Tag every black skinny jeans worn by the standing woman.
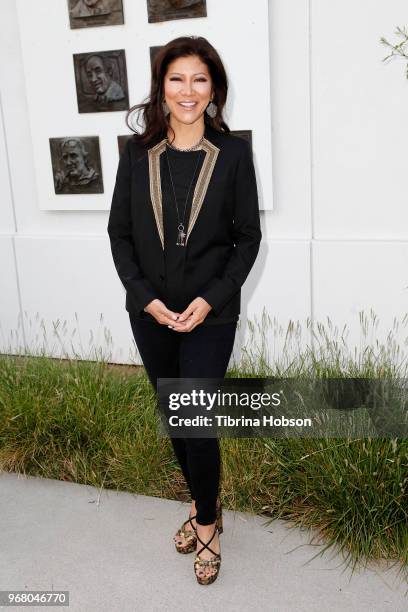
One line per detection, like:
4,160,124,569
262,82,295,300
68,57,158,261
129,313,237,525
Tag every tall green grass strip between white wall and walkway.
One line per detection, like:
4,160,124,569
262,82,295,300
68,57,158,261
0,308,408,577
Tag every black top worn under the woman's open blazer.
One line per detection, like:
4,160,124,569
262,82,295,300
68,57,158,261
142,145,238,326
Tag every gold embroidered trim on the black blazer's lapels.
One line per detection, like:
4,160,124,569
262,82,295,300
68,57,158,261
148,138,220,249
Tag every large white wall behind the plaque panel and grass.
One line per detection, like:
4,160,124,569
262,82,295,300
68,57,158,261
0,0,408,363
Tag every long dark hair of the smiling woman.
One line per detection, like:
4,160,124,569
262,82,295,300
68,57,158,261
126,36,230,145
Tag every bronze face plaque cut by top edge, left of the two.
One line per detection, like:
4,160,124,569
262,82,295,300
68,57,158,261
67,0,124,29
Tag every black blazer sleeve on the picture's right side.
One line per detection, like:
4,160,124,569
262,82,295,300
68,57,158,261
200,140,262,316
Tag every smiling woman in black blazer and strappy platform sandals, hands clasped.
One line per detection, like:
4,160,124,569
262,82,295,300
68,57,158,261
108,36,261,584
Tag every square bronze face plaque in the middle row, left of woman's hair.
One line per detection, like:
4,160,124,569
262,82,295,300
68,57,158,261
73,49,129,113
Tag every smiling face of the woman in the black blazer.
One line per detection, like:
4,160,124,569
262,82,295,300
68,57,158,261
163,55,212,124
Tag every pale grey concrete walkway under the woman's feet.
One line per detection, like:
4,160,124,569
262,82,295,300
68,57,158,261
0,472,408,612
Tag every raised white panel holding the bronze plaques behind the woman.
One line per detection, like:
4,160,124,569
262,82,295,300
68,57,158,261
16,0,273,211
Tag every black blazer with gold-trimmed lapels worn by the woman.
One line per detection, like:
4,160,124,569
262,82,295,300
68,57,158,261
107,120,262,321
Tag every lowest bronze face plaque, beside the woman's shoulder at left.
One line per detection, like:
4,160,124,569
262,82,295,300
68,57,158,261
49,136,103,195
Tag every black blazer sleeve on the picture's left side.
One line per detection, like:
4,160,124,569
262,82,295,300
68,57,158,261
107,141,158,312
